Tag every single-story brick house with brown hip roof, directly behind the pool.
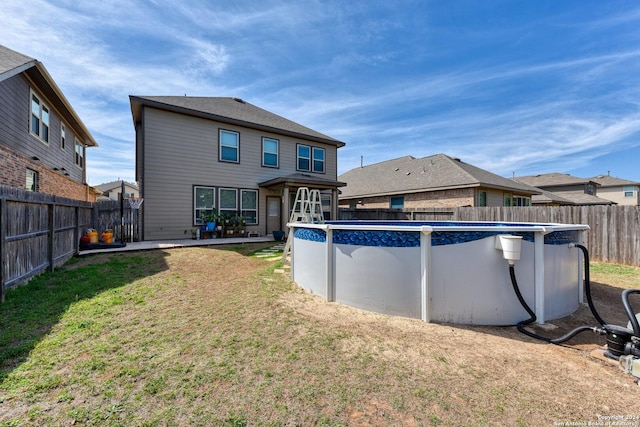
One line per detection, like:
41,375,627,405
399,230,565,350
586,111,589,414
338,154,541,209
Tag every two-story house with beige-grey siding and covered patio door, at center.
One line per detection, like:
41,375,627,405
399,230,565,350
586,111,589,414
130,96,344,240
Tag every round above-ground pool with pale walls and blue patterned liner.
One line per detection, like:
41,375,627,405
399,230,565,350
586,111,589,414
288,221,589,325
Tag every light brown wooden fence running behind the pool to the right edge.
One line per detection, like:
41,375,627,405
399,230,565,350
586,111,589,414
338,206,640,266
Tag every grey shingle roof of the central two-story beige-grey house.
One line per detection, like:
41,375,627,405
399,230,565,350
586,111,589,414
129,95,345,147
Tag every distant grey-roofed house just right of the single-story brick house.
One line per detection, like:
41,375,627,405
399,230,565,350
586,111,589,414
512,172,615,206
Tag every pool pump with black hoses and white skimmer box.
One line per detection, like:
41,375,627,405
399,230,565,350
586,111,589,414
495,235,640,385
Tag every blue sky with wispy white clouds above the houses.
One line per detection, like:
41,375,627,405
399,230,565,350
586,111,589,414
0,0,640,185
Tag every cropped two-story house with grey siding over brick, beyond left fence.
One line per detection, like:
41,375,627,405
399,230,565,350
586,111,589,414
0,45,98,201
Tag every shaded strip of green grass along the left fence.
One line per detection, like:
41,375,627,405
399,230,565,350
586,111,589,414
0,251,167,382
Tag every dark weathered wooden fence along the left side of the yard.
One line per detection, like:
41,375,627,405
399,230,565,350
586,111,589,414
0,186,138,301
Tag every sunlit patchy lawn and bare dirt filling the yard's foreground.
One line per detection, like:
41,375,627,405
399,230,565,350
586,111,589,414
0,247,640,427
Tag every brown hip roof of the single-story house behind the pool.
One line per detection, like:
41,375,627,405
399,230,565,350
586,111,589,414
338,154,541,199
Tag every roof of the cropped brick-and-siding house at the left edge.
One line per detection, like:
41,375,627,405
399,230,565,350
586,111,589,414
0,45,98,147
